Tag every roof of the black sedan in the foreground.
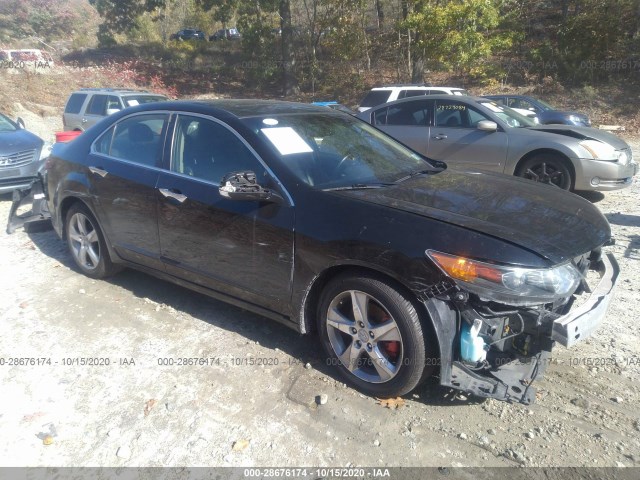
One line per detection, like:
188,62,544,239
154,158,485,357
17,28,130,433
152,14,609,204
124,99,332,118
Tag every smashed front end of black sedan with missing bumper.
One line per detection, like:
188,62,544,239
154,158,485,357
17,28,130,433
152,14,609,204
424,248,619,405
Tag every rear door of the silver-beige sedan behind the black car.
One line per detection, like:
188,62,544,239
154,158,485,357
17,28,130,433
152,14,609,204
371,99,433,155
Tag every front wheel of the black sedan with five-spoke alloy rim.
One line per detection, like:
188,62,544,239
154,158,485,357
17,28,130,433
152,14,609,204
318,275,435,397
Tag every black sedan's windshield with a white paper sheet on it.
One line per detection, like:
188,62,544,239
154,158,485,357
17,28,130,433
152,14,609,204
244,113,442,189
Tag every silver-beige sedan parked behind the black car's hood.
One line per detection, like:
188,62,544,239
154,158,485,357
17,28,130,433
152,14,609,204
358,95,638,190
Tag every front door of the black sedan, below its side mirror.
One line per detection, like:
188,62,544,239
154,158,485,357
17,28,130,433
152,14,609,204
157,114,294,310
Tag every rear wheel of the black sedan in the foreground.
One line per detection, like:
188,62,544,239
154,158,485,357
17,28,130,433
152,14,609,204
65,203,117,278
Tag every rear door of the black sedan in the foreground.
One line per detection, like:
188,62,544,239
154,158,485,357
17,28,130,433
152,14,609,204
88,113,169,269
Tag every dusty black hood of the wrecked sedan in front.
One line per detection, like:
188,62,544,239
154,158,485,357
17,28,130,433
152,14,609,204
340,170,611,264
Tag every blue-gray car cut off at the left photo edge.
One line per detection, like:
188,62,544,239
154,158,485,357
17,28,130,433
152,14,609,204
0,114,51,193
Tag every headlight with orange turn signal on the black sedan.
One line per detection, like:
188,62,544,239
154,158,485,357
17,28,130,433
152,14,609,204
426,250,581,305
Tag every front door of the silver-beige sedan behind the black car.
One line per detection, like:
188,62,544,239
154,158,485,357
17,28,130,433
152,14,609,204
427,99,508,172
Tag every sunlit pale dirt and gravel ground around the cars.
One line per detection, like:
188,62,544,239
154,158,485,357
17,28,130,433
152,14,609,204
0,98,640,467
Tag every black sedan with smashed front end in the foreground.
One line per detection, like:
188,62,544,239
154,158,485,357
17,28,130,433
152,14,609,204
11,100,618,403
